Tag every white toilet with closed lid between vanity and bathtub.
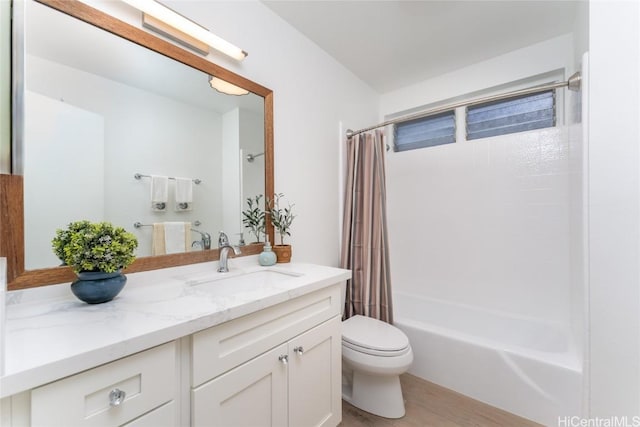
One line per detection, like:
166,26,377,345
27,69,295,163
342,315,413,418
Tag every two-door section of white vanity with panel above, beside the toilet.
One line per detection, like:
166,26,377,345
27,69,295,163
191,287,342,427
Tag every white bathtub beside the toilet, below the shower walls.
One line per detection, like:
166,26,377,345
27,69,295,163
393,292,582,426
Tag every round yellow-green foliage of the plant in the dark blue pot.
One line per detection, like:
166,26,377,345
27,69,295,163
51,220,138,273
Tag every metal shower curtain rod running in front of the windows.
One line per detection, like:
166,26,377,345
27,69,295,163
347,71,581,138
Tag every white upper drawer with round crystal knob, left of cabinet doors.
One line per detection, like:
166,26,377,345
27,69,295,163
31,342,177,426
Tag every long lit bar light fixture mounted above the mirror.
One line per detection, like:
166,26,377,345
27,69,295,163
122,0,247,61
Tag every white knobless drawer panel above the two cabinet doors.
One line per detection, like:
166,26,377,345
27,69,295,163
191,285,340,387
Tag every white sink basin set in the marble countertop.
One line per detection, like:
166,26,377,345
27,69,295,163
187,269,301,296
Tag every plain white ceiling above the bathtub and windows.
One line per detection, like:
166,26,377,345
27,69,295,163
263,0,578,93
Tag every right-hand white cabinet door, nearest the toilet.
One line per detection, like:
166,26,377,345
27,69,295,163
289,317,342,427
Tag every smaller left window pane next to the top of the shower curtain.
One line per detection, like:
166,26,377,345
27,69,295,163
393,110,456,151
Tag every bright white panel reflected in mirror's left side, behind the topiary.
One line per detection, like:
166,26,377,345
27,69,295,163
24,91,105,270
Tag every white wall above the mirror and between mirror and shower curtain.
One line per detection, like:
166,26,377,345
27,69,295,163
80,0,379,265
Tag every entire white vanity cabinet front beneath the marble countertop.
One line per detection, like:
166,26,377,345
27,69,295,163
0,274,342,427
